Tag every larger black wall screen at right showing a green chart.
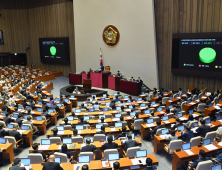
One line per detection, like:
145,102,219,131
172,33,222,77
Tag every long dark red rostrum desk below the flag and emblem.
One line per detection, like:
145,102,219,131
69,71,141,96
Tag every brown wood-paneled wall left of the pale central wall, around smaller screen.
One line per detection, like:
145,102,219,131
0,0,76,75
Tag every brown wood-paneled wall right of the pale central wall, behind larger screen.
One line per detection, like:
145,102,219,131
155,0,222,91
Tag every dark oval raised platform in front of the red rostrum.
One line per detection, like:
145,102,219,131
60,85,107,101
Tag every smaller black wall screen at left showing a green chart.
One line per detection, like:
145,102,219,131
39,37,70,65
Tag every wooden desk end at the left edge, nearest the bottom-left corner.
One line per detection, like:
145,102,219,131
0,143,14,163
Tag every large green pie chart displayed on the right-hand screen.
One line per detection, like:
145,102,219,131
199,47,216,63
